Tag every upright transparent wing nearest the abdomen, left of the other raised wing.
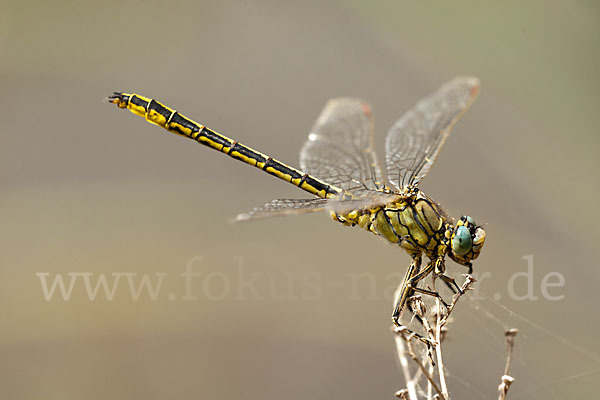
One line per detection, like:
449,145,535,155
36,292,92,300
300,98,383,194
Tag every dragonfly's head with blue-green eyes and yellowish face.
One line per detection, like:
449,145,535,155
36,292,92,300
450,215,485,265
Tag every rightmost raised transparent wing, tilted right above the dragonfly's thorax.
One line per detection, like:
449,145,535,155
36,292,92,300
385,77,479,188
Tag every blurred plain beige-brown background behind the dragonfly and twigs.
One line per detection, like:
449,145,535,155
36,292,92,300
0,0,600,399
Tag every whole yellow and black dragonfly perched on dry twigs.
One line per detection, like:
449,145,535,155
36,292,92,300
107,77,485,329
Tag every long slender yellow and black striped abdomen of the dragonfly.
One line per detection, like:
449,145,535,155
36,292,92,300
108,92,342,198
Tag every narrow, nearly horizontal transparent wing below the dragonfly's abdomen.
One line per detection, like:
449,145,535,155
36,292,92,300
234,192,397,222
